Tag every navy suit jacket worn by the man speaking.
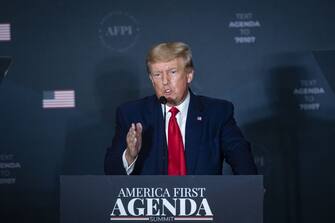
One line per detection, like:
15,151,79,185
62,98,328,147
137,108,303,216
105,93,257,175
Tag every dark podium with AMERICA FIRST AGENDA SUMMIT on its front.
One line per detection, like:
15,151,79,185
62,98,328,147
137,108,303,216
60,175,264,223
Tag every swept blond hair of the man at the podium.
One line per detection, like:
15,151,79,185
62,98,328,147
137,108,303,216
146,42,193,74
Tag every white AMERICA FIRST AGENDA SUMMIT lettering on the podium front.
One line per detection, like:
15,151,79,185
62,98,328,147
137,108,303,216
110,187,214,222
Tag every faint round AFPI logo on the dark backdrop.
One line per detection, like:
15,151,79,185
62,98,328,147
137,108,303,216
99,12,140,51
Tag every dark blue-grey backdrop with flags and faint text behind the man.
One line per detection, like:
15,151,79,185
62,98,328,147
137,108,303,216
0,0,335,223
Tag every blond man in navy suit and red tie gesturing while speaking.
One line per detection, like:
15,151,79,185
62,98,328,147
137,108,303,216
105,42,257,175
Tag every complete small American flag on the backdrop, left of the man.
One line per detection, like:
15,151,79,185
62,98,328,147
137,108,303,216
43,90,75,108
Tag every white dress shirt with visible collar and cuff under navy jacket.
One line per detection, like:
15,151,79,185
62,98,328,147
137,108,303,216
122,92,190,175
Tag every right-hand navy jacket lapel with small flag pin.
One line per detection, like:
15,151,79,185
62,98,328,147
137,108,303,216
185,92,204,175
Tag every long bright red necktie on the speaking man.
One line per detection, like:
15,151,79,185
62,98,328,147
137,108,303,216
168,107,186,176
